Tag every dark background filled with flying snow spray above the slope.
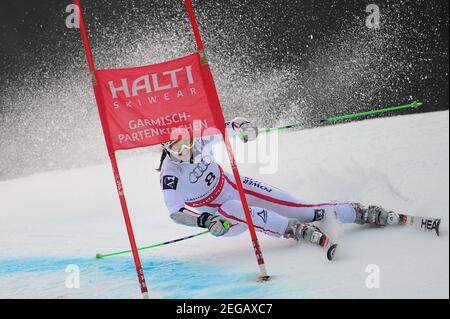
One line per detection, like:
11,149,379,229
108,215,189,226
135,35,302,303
0,0,449,179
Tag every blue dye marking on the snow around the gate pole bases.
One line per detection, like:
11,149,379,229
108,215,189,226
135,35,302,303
0,257,282,299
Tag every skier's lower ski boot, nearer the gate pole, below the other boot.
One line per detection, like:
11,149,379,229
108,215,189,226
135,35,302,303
284,218,337,261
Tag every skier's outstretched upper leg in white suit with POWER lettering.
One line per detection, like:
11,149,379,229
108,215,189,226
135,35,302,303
225,174,356,223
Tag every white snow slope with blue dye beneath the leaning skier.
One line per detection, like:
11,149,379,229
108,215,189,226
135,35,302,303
0,111,449,298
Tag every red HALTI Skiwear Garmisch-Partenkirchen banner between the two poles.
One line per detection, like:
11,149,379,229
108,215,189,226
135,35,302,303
95,53,223,151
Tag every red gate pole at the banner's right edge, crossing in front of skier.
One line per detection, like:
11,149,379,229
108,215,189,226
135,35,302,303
185,0,270,281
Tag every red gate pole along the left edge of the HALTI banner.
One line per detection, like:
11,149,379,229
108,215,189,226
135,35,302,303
74,0,149,299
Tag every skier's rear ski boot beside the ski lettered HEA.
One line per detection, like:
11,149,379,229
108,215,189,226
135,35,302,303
352,203,404,226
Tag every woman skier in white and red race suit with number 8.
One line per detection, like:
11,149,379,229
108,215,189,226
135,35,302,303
159,118,401,247
